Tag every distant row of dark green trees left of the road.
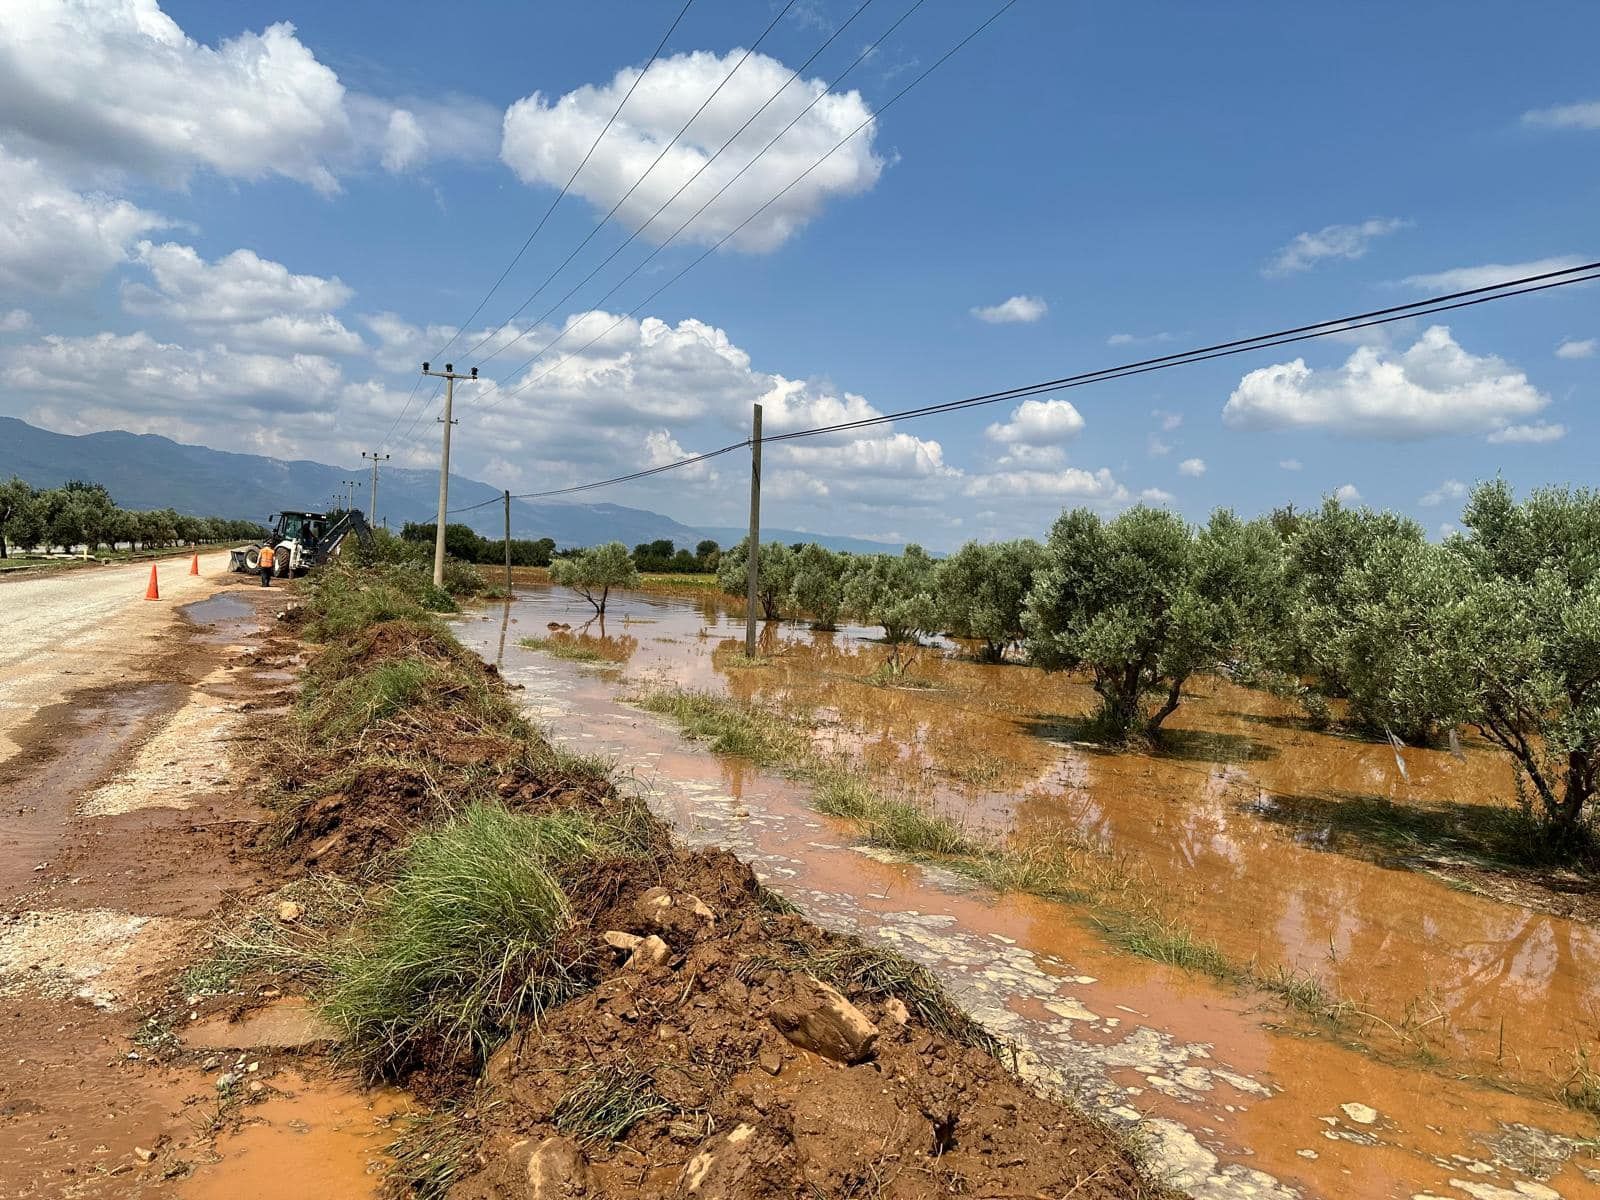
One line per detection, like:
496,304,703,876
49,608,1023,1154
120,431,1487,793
0,475,267,558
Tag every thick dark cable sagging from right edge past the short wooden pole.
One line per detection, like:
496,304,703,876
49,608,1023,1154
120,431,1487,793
486,261,1600,499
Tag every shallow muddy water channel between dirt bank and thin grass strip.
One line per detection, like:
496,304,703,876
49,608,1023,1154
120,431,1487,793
461,605,1600,1200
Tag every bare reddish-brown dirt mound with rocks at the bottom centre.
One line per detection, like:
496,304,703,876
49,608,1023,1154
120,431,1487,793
450,851,1147,1200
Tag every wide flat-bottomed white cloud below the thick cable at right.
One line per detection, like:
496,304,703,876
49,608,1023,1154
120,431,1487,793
1222,325,1549,438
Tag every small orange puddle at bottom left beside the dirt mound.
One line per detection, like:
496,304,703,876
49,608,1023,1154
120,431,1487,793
178,1072,411,1200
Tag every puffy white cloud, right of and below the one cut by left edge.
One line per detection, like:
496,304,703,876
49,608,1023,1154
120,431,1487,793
122,242,366,354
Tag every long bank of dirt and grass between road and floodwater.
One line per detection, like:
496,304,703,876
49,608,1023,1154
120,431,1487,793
186,539,1162,1200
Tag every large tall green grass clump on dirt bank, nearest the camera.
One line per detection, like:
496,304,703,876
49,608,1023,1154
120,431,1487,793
318,803,595,1075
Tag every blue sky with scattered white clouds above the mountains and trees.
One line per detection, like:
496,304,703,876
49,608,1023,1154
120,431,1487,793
0,0,1600,549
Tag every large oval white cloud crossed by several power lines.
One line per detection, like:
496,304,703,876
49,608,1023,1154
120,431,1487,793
501,48,883,253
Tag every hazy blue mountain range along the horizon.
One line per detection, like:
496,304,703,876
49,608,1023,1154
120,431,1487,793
0,416,901,554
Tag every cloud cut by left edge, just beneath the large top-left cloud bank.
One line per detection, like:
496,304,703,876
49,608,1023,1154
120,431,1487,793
0,146,166,296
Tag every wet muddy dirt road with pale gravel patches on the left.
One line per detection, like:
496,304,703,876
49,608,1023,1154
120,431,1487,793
0,554,408,1200
